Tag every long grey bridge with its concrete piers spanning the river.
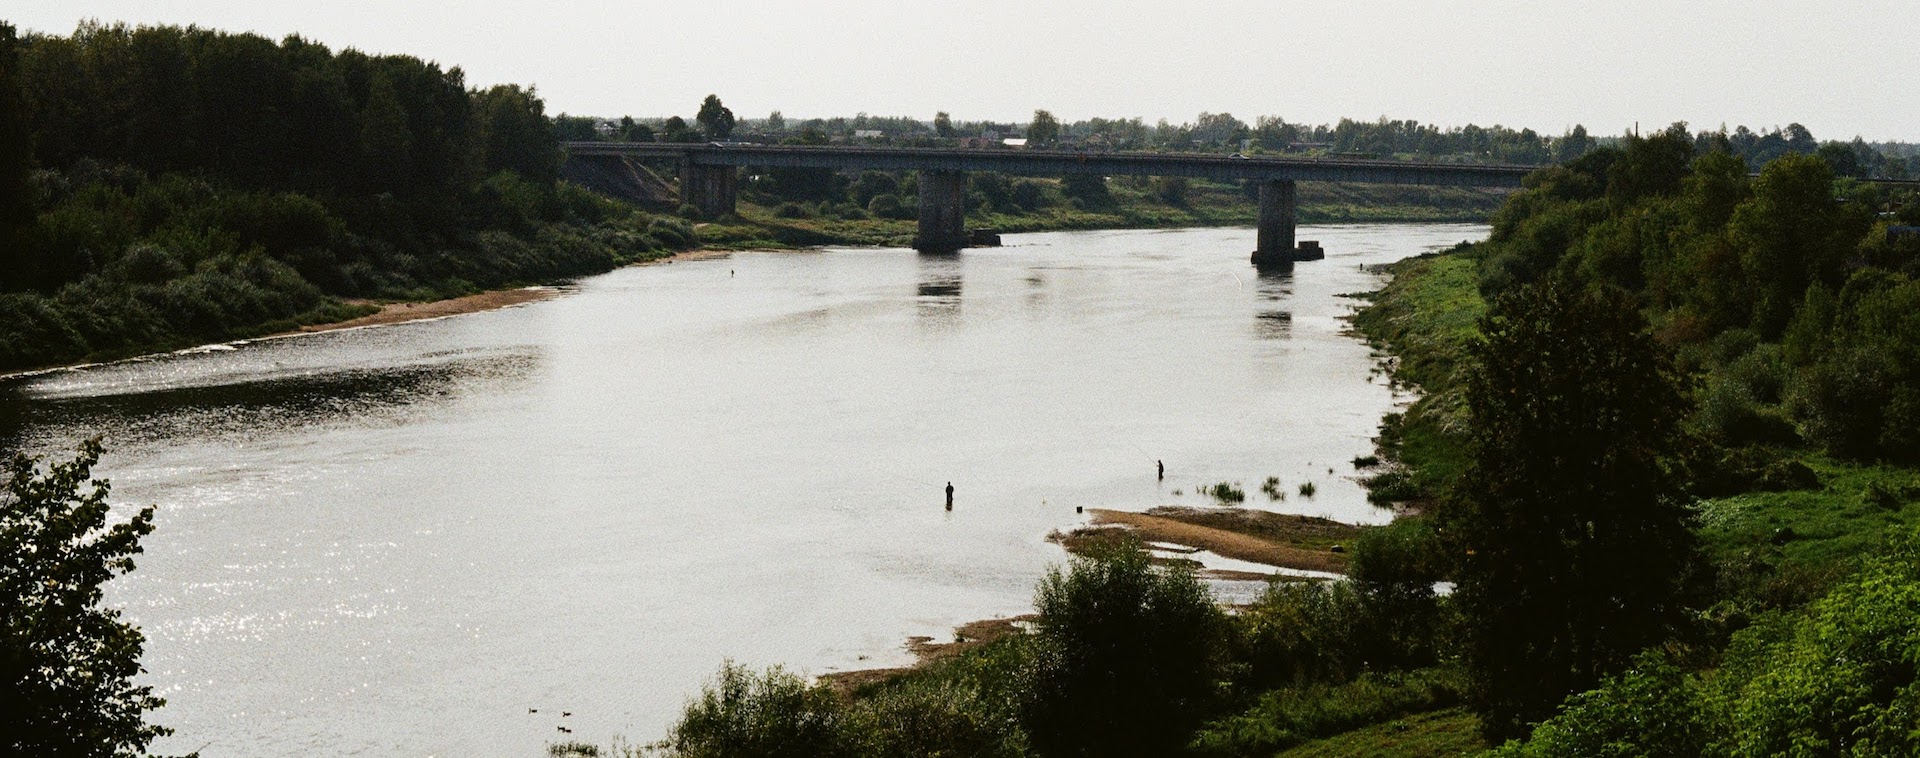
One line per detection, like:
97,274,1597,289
564,142,1538,265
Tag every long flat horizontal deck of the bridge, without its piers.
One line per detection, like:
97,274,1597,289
564,142,1538,186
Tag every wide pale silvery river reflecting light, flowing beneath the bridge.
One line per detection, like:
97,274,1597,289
0,225,1486,758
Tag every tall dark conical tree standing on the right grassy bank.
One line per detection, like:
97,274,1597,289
1446,280,1697,743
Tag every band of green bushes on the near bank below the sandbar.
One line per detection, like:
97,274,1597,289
645,532,1461,758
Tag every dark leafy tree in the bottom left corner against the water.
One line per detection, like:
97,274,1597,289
0,439,169,756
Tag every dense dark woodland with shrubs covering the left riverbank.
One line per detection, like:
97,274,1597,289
0,23,691,376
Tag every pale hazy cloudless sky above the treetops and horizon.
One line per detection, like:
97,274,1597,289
0,0,1920,142
